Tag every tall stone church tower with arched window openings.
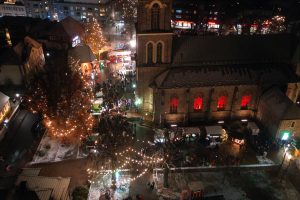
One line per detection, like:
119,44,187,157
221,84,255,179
137,0,173,113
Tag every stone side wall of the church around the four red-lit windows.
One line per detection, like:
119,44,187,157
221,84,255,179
154,85,257,124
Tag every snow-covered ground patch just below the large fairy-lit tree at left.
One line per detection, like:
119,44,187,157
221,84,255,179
31,135,78,164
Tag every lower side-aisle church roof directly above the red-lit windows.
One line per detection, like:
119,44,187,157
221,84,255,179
150,64,298,89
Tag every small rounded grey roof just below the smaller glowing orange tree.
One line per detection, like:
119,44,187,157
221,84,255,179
68,44,96,63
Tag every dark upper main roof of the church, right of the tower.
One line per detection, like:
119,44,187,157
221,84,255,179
172,34,294,66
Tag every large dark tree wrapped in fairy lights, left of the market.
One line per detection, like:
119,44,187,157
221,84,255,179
25,52,94,143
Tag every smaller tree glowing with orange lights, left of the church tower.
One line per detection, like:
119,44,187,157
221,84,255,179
84,18,109,56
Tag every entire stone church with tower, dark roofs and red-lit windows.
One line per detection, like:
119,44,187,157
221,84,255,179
137,0,300,130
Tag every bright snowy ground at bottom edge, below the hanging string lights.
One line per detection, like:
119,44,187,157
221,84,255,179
88,170,130,200
